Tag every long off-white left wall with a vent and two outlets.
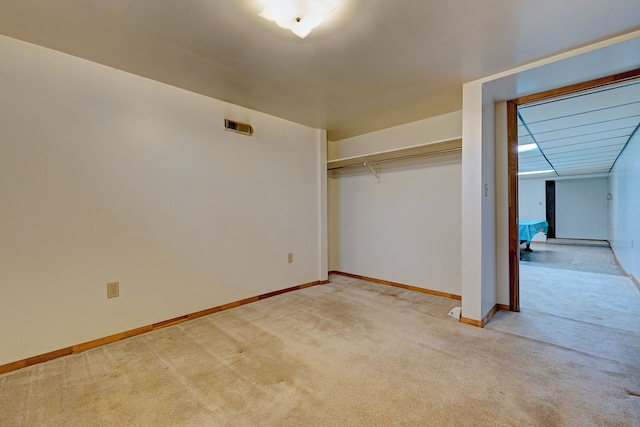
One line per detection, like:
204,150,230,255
0,37,326,364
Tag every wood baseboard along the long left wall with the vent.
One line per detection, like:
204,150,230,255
0,280,329,375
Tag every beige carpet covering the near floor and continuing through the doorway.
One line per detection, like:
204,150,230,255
0,254,640,427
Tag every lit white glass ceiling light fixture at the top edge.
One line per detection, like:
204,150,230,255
258,0,339,39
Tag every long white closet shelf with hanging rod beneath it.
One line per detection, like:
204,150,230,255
327,138,462,171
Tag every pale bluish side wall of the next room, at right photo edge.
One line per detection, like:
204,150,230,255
609,132,640,279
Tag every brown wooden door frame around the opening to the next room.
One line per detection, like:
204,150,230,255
507,68,640,311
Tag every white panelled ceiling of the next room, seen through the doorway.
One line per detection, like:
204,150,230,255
518,79,640,176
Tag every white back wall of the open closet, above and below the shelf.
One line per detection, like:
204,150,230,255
328,115,461,295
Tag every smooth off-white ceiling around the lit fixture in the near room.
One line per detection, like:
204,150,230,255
0,0,640,140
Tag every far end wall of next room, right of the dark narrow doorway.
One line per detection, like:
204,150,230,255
556,177,609,240
